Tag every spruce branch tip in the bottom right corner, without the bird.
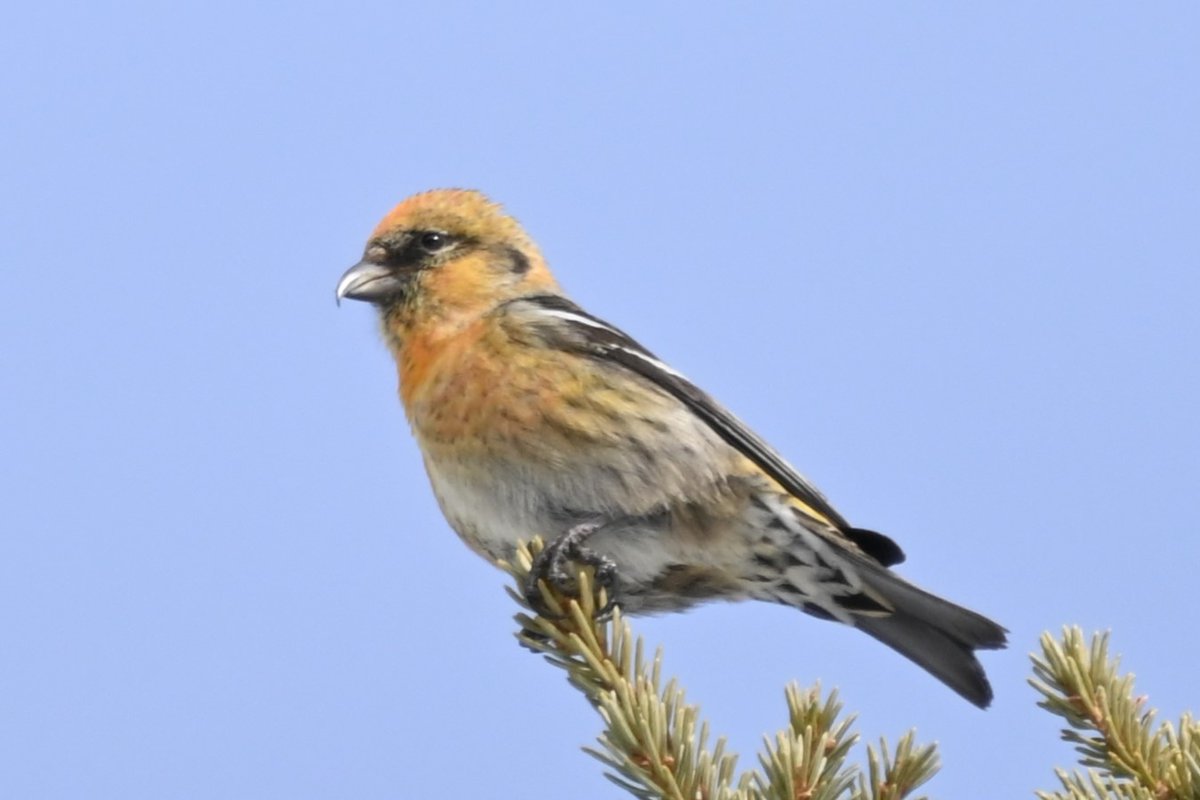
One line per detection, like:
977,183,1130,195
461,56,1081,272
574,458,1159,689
1030,627,1200,800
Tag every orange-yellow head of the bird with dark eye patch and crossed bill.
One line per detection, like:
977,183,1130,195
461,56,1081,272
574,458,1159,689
337,190,558,323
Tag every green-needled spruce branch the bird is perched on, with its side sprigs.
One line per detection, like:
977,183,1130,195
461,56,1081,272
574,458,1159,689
504,539,938,800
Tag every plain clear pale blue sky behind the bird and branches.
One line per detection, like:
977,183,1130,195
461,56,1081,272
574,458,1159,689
0,2,1200,800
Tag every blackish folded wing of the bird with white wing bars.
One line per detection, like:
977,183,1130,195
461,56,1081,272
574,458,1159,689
509,295,904,566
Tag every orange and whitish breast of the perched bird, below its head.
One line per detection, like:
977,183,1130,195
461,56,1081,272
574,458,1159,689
401,316,737,558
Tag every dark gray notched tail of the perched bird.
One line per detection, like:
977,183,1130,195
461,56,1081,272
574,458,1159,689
854,567,1007,709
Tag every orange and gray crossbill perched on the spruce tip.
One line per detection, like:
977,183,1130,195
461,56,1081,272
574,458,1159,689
336,188,1007,708
